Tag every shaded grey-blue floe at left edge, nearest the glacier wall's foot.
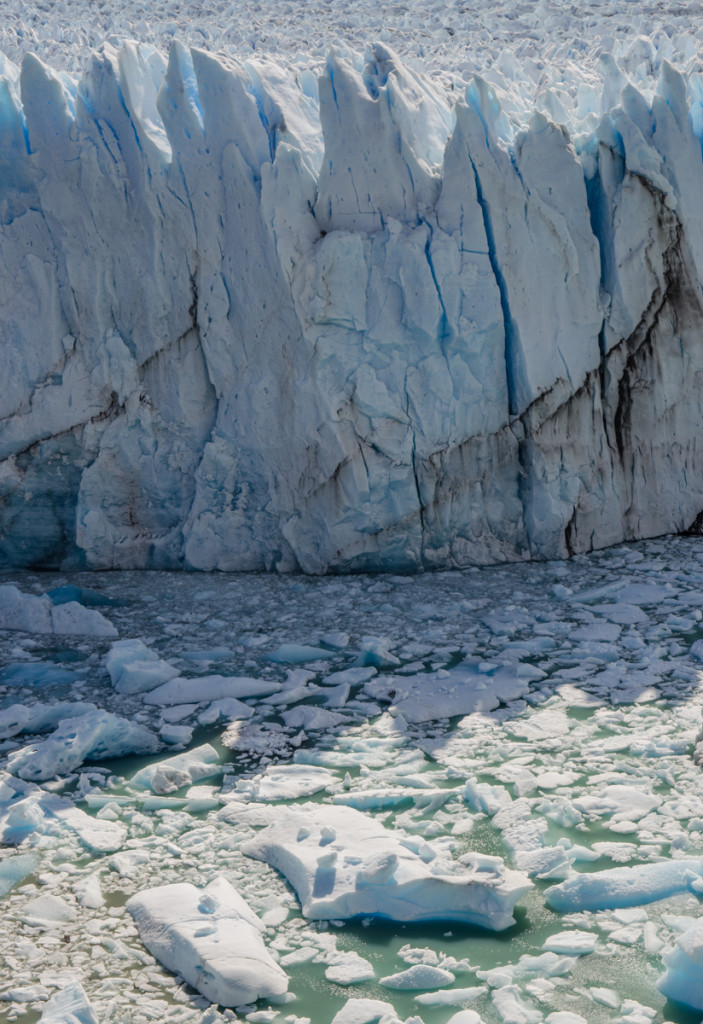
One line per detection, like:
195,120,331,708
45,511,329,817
0,584,118,637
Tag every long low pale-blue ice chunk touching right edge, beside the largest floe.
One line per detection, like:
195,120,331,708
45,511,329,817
545,859,703,913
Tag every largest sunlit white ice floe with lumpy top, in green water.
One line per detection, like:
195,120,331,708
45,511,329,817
241,804,532,931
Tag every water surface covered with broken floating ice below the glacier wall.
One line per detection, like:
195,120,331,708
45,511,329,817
0,538,703,1024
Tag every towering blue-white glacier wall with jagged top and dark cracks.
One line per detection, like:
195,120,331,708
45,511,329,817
0,44,703,572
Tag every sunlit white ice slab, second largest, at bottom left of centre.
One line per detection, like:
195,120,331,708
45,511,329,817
126,877,288,1007
